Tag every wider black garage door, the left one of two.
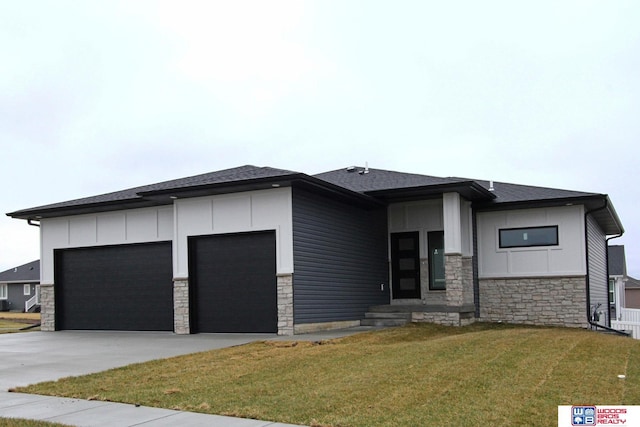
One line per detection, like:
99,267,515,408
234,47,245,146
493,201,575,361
55,242,173,331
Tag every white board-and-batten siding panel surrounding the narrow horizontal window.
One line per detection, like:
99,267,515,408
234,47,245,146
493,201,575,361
477,205,586,279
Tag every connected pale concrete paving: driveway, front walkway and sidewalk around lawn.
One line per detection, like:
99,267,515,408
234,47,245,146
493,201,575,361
0,327,379,427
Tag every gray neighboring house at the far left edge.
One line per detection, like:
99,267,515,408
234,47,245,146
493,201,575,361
0,261,40,312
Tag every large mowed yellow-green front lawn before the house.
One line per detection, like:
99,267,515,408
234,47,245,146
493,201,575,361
17,324,640,427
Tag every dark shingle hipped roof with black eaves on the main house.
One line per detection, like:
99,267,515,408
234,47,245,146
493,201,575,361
7,165,623,235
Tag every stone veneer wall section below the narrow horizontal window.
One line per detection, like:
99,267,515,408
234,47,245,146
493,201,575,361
479,276,587,327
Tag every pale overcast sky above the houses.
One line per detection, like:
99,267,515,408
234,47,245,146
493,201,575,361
0,0,640,277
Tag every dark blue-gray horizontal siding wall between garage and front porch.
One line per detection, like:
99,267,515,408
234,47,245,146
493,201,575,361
293,188,389,324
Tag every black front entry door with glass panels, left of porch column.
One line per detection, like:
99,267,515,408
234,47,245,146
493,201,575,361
391,231,420,299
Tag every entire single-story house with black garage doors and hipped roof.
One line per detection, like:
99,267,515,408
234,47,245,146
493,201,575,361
8,166,624,335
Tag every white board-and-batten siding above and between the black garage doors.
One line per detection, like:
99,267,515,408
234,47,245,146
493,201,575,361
40,188,293,283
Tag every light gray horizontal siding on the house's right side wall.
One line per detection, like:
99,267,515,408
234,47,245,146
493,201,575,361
586,215,609,325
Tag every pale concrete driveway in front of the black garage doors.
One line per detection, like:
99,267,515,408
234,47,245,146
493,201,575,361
0,331,278,391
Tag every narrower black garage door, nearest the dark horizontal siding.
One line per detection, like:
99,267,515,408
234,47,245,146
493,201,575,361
189,231,278,332
